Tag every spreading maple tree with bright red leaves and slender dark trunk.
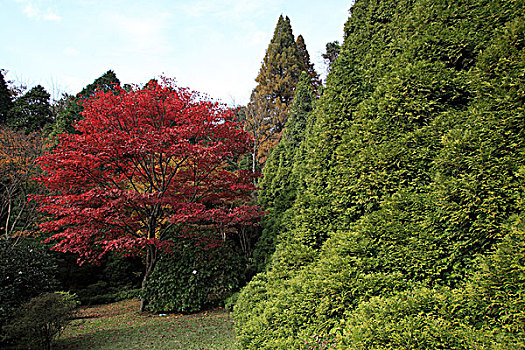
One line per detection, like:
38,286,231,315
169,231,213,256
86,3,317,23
35,80,262,309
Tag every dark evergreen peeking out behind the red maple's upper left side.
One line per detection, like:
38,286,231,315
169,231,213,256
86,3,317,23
53,70,120,135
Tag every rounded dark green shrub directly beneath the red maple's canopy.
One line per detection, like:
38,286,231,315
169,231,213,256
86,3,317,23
145,239,247,312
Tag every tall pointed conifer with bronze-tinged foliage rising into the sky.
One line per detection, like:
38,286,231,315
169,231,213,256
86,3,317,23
246,15,316,170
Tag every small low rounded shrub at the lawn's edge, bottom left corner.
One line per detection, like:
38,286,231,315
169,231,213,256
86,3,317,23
4,293,78,349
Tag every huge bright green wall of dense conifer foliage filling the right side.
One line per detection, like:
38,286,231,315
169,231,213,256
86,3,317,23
234,0,525,349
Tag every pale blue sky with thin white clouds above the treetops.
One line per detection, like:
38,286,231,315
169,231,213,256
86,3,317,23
0,0,351,105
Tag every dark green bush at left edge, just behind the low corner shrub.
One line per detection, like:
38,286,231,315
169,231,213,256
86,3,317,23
0,239,57,338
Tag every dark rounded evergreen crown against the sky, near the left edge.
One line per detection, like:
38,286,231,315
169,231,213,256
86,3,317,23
7,85,53,134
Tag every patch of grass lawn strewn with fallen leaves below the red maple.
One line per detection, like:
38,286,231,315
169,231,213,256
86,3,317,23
55,300,235,350
